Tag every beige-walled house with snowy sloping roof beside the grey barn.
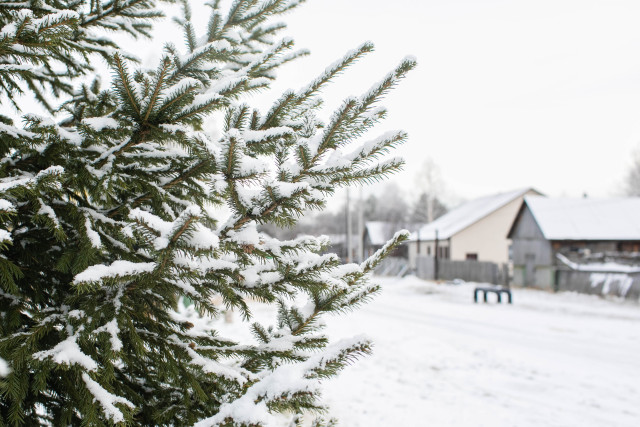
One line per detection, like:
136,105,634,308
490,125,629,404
407,188,541,268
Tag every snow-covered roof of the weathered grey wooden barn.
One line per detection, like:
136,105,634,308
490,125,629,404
525,197,640,240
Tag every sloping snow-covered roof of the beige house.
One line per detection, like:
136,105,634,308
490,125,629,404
410,188,535,240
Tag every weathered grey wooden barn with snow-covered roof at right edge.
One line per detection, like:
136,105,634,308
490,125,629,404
508,197,640,288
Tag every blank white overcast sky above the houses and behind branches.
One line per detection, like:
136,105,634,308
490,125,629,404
15,0,640,207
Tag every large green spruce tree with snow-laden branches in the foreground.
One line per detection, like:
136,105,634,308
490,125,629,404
0,0,415,426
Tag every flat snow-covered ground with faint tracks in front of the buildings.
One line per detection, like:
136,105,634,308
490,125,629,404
221,277,640,427
